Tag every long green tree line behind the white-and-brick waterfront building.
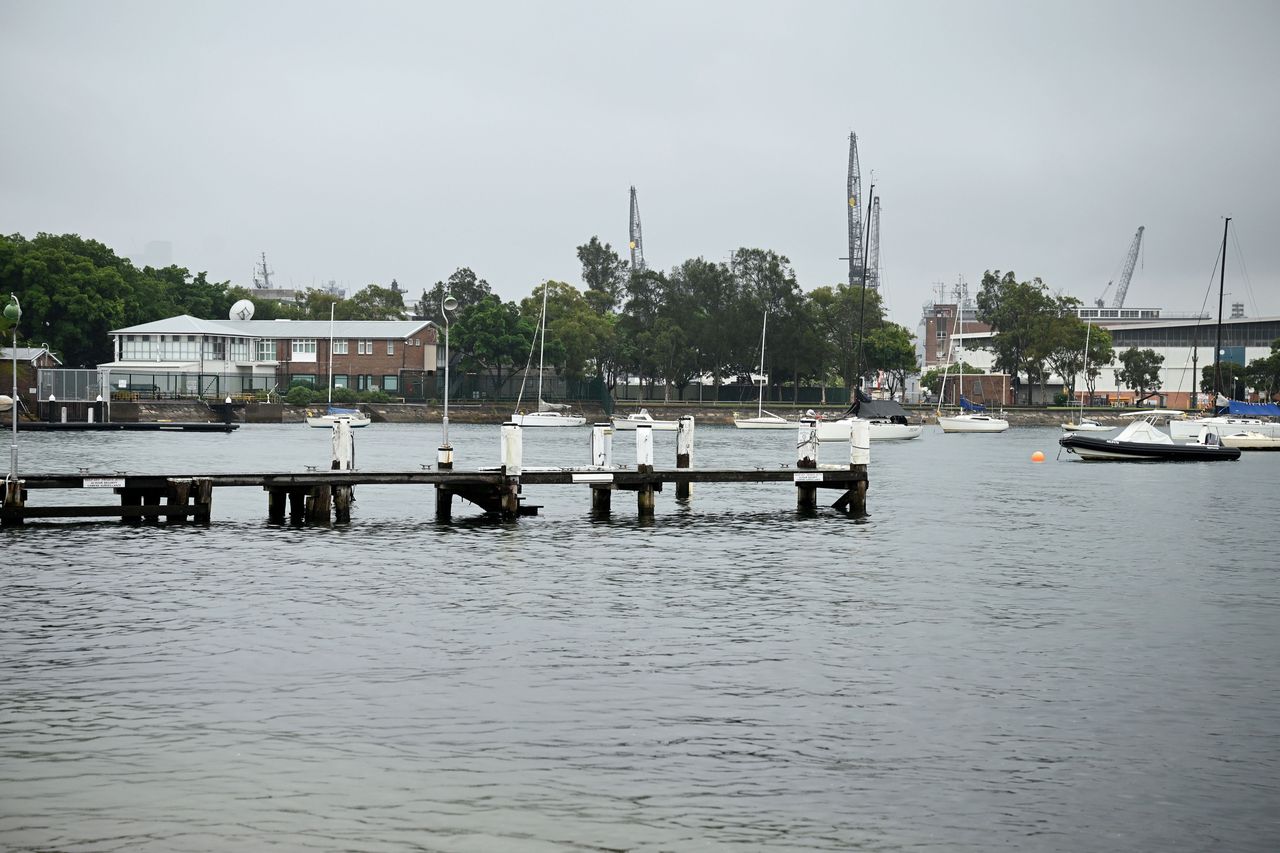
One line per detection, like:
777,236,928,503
0,227,916,396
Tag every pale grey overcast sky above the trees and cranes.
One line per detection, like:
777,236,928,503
0,0,1280,330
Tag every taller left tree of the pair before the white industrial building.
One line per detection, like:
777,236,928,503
977,270,1061,403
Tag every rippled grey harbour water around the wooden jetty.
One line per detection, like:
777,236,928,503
0,425,1280,852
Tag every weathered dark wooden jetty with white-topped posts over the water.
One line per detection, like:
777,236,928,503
0,418,870,526
